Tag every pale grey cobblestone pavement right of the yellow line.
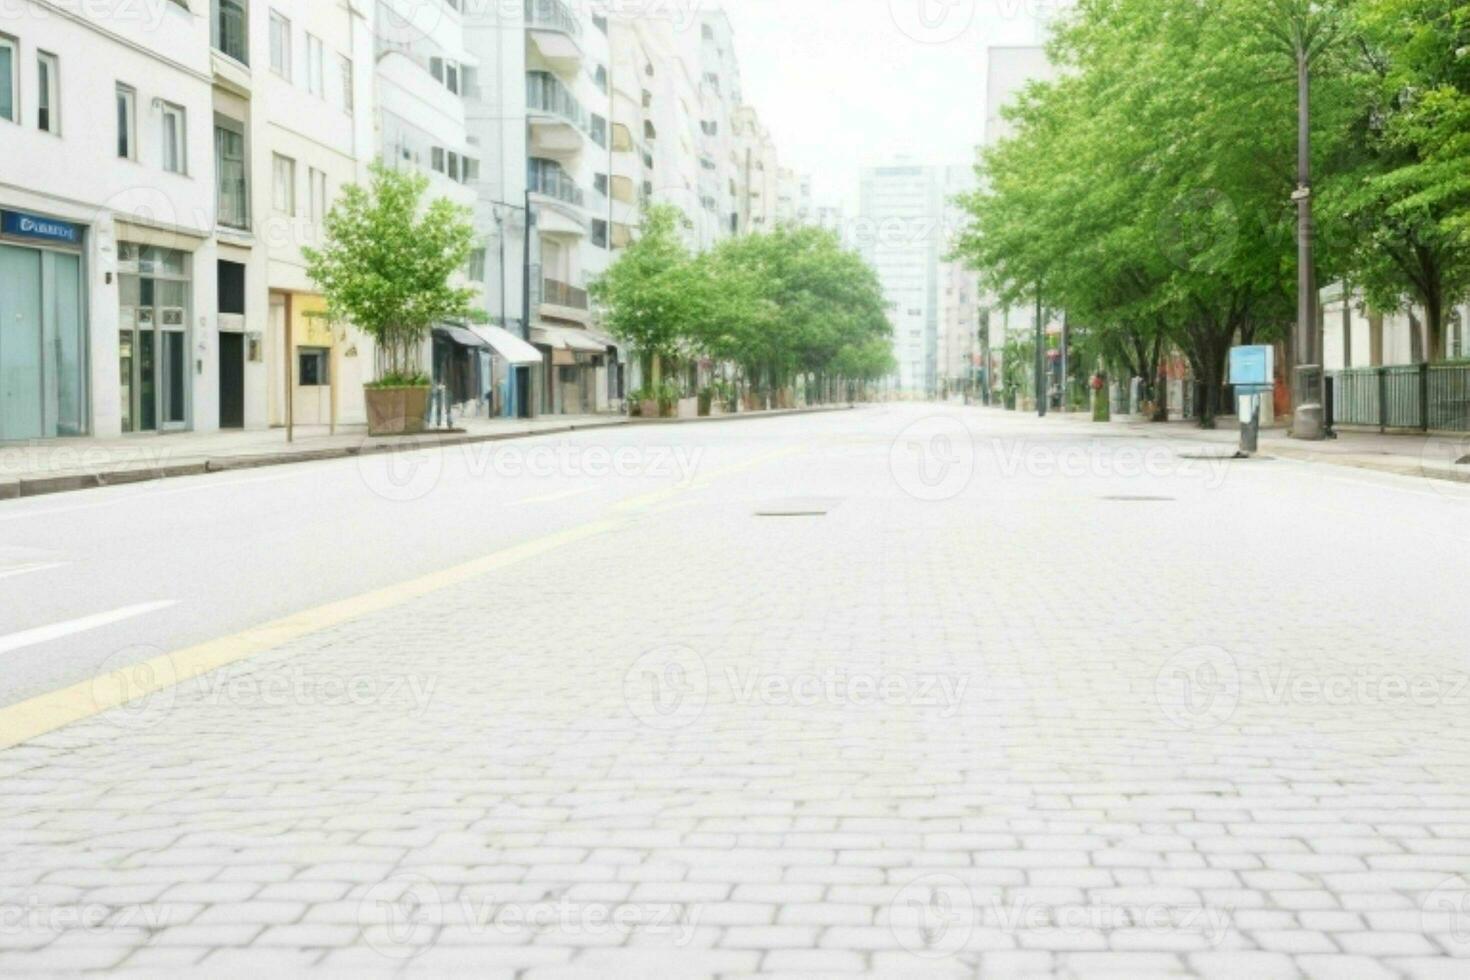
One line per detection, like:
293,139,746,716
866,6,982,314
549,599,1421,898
0,406,1470,979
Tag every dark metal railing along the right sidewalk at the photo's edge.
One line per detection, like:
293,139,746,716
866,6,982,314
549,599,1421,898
1329,364,1470,432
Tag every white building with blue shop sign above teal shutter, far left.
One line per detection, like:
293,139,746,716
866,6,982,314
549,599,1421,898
0,0,218,439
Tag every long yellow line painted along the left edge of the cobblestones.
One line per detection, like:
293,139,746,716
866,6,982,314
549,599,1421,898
0,445,807,749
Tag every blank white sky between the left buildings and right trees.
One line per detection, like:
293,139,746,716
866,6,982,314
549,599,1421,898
722,0,1066,215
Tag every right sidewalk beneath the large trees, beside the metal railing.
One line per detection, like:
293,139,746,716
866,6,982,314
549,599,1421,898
1005,413,1470,483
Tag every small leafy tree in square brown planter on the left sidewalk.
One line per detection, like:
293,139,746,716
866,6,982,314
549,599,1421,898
301,160,484,432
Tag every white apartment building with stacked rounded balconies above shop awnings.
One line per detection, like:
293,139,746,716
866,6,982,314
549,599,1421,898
463,0,617,414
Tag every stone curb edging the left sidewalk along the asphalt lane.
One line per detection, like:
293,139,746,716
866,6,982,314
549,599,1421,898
0,406,856,500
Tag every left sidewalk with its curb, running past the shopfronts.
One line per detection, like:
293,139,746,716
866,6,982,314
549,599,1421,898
0,406,848,500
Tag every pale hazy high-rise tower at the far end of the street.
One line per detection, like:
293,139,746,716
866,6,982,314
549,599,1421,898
857,159,944,395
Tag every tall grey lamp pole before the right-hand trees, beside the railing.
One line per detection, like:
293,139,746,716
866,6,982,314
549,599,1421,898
1291,35,1324,439
